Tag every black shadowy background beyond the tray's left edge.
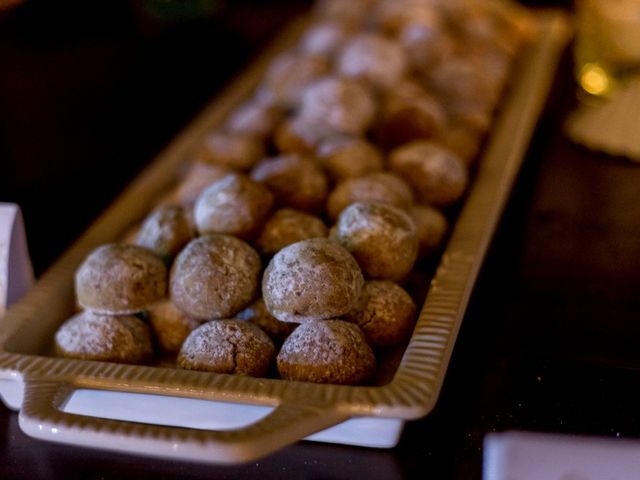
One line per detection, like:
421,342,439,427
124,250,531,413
0,0,307,273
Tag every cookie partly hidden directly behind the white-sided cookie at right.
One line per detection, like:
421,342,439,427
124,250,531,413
327,172,413,220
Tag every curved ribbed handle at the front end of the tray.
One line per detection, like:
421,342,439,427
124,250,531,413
19,379,348,463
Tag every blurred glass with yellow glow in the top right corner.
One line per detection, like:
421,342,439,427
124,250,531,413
575,0,640,96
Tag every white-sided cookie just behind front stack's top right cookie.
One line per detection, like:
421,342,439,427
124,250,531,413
336,202,418,281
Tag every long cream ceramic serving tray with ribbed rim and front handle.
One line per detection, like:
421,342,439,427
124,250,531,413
0,11,568,463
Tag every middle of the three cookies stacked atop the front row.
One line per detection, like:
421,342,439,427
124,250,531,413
170,235,261,320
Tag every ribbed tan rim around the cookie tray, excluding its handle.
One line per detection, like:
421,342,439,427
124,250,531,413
0,11,568,464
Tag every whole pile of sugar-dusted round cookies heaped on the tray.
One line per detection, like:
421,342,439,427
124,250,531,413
55,0,528,384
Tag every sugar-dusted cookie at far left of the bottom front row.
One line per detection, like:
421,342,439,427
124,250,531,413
55,310,153,363
